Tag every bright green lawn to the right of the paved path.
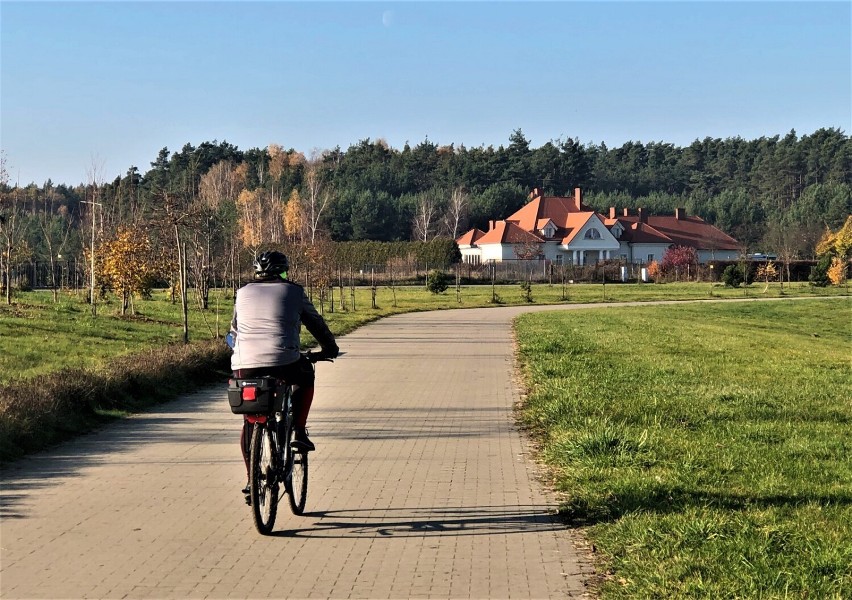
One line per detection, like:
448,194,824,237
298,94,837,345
516,299,852,598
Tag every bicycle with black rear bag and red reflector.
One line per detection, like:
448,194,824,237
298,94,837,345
228,352,333,535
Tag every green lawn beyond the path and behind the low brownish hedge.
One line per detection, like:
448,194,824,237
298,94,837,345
0,283,845,384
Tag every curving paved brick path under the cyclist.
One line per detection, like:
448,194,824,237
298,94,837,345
0,307,592,600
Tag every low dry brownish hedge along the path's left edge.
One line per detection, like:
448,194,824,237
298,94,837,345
0,340,230,462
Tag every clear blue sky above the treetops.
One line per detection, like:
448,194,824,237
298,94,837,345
0,0,852,185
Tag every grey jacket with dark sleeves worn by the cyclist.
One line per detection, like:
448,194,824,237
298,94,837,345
231,278,339,370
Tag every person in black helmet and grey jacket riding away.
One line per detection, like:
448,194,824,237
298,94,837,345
231,251,339,494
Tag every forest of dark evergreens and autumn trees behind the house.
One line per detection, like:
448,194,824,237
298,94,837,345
0,128,852,300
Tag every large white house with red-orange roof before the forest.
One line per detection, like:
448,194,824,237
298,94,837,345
456,188,739,265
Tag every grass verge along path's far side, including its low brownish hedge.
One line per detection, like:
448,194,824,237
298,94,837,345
0,283,844,461
